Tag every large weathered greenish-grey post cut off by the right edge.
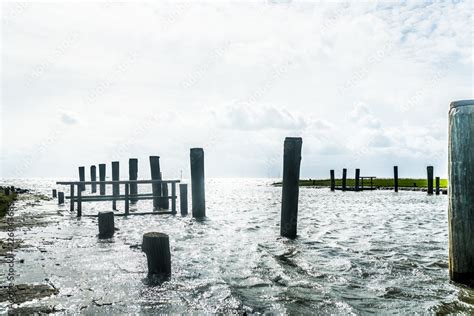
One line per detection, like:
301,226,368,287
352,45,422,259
448,100,474,286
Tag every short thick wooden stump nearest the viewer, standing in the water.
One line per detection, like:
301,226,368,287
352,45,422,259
142,232,171,277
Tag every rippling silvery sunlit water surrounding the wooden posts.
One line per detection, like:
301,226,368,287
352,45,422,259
2,179,474,314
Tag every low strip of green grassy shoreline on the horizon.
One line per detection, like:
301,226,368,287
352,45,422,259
273,178,448,189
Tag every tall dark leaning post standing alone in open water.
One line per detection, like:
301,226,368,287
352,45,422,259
280,137,303,238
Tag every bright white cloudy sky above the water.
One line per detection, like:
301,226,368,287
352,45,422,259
0,0,474,179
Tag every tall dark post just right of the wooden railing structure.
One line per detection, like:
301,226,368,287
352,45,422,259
190,148,206,217
